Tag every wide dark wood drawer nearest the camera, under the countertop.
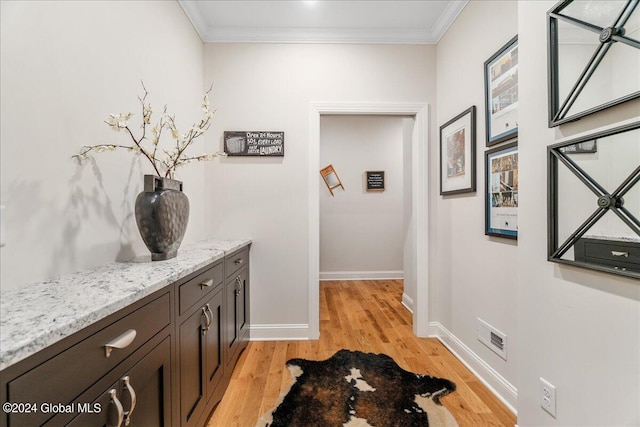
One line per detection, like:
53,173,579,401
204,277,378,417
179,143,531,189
7,294,171,425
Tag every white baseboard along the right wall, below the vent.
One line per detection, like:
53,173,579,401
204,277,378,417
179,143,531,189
429,322,518,415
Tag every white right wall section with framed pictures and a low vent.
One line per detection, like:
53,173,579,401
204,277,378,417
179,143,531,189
430,1,520,406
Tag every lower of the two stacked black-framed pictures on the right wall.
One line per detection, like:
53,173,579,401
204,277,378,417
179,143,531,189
484,142,518,239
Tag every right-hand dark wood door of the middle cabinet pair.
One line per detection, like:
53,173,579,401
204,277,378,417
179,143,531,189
204,287,224,400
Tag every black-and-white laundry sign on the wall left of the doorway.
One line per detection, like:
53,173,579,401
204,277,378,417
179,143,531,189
224,131,284,157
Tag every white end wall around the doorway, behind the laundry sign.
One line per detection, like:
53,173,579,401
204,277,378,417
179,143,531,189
205,44,435,337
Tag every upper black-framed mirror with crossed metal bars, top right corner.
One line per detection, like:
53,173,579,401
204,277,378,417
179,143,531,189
547,0,640,127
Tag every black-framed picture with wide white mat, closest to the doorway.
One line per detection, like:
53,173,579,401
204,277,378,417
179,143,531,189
440,105,476,195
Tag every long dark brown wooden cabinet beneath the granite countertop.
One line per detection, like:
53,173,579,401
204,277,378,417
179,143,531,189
0,246,250,427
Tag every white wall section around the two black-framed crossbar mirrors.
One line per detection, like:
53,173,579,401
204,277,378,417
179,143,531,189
517,1,640,427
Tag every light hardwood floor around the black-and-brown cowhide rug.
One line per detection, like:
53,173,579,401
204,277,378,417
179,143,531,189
208,280,516,427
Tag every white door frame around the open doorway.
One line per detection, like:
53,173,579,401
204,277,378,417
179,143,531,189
308,102,429,339
